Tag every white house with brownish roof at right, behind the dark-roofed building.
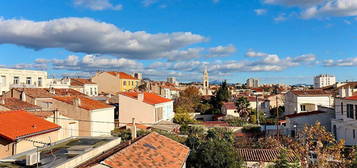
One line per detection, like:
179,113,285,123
285,90,334,115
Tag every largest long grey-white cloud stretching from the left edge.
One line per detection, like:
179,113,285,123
0,17,207,59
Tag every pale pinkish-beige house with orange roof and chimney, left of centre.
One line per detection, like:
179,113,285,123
119,92,174,125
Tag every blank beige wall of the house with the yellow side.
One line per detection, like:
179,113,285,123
91,72,120,94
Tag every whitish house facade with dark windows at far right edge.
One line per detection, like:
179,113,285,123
331,99,357,145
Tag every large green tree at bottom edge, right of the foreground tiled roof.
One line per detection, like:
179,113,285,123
185,128,242,168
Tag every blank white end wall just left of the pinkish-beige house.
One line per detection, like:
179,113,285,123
91,107,115,136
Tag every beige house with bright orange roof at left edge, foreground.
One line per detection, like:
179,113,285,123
0,111,61,158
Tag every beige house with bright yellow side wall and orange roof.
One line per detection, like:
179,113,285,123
91,72,140,94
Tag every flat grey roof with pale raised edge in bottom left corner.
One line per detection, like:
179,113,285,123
0,137,120,168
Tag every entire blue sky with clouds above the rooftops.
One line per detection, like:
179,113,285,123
0,0,357,84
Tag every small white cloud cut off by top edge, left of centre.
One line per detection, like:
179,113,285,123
73,0,123,11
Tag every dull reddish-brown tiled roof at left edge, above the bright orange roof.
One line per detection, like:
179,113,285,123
0,98,41,110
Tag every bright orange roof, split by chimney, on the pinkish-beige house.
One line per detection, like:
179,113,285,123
120,92,172,105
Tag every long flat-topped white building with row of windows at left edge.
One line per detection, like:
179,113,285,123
0,68,48,95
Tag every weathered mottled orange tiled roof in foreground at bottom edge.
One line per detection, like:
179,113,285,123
103,132,190,168
